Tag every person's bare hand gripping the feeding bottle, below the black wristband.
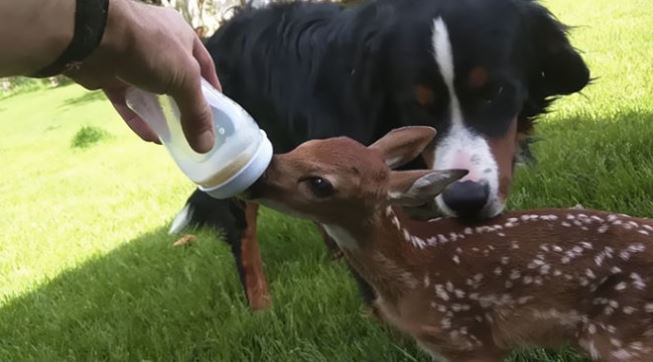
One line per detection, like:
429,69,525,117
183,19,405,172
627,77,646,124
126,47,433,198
64,0,221,152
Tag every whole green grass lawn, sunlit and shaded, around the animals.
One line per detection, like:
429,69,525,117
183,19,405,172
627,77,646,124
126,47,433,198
0,0,653,362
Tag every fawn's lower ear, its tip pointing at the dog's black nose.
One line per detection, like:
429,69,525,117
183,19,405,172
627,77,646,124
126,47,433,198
388,169,468,206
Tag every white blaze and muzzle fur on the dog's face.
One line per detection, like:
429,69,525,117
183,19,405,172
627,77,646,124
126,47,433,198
432,18,503,216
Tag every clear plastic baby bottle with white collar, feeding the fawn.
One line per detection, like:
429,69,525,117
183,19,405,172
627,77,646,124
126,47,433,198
126,79,272,199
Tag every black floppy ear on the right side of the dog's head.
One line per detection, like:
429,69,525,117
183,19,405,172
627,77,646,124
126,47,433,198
522,1,590,96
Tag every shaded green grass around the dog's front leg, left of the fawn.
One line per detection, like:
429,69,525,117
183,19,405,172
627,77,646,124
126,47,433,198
0,212,422,361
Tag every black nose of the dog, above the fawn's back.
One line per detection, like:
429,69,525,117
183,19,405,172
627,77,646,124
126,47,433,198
442,181,490,217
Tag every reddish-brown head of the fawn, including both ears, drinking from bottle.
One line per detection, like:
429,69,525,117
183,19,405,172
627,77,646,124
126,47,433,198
247,127,467,224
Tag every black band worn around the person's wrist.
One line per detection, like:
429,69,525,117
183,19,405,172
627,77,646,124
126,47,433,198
33,0,109,78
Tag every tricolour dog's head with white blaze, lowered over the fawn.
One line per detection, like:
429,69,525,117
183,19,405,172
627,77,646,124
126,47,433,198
366,0,589,218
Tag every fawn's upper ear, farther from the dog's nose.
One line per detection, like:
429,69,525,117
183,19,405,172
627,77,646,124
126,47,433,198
369,126,436,169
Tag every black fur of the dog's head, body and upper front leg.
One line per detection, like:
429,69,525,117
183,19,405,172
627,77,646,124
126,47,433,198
171,0,589,306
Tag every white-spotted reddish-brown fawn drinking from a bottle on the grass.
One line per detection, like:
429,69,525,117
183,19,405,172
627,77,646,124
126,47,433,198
246,127,653,361
